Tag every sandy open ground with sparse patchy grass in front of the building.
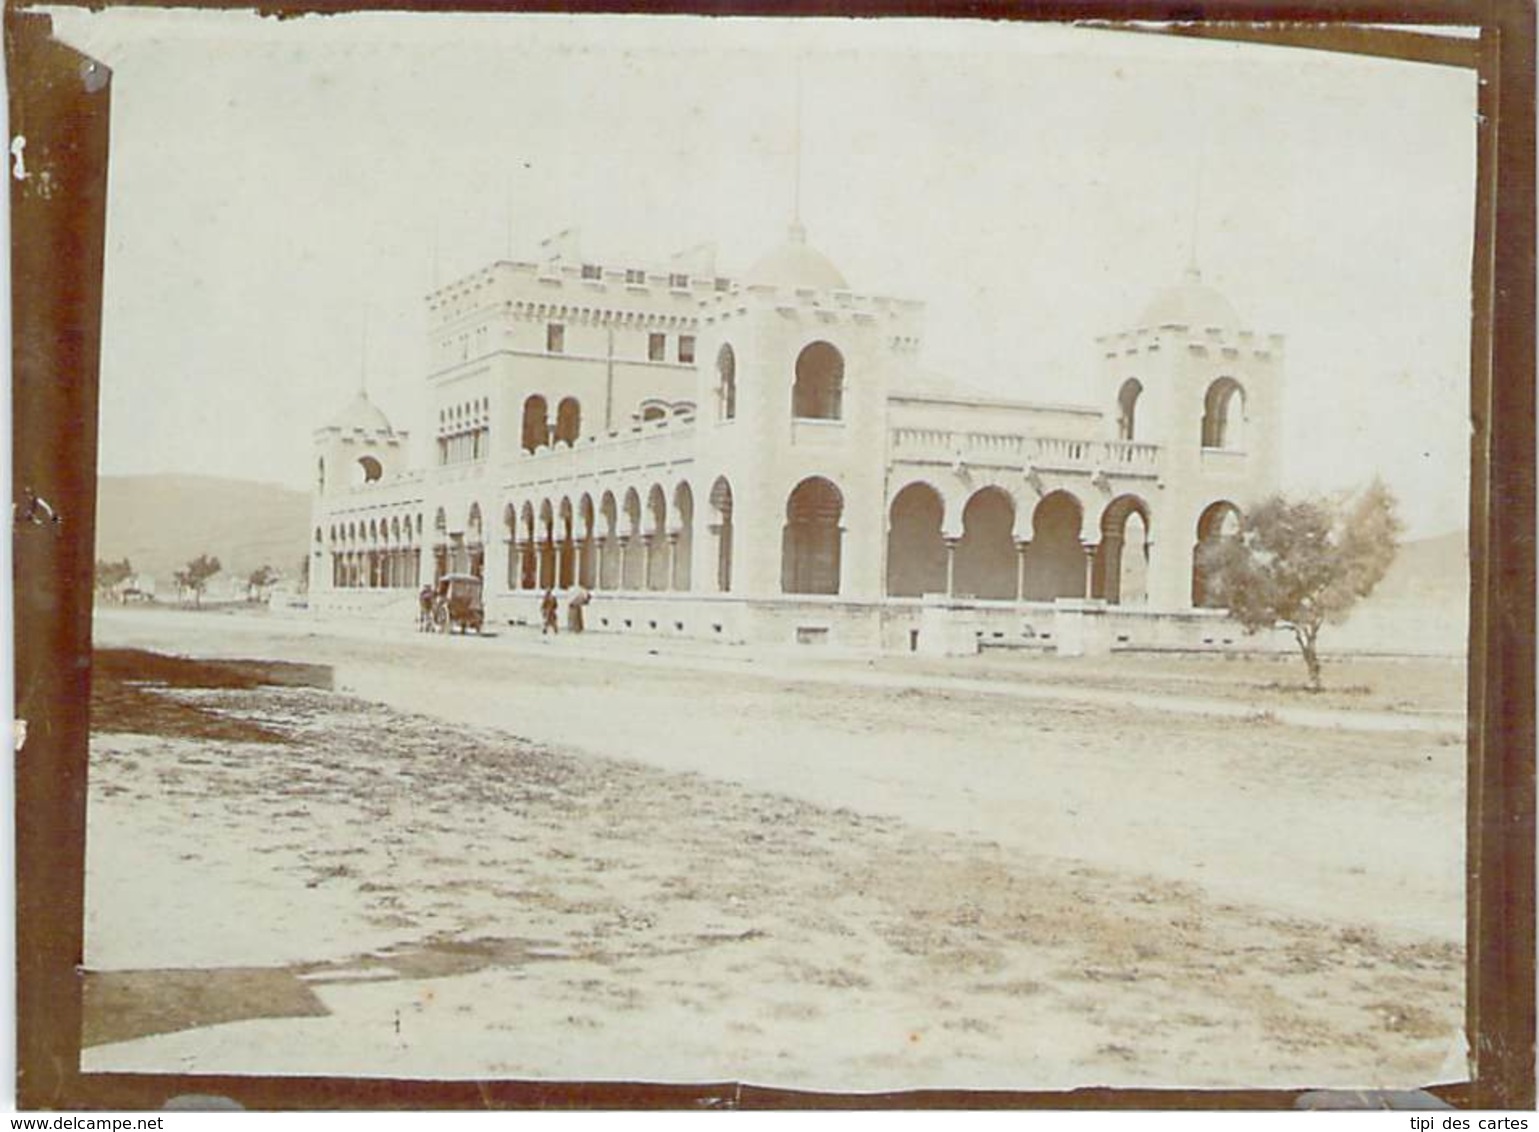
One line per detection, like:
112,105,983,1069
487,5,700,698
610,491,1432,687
85,614,1464,1090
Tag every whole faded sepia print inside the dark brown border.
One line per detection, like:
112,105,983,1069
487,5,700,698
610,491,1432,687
12,8,1479,1094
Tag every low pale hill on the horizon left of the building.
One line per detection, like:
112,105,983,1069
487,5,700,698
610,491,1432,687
95,475,309,588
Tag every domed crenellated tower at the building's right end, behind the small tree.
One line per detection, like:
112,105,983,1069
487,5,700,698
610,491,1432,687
1097,266,1284,609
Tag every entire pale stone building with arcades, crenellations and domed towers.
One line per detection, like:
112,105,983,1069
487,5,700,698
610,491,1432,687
311,225,1282,652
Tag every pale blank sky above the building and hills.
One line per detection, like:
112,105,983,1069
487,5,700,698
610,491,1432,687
52,9,1476,535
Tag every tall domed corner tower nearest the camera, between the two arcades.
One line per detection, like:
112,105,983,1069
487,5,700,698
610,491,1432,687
697,225,919,600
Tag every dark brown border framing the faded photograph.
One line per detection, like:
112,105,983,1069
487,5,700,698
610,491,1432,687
5,0,1536,1110
